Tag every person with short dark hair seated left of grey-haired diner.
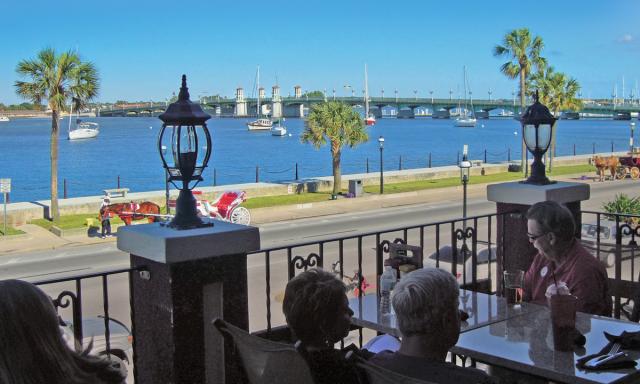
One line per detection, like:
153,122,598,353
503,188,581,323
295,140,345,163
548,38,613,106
282,269,358,384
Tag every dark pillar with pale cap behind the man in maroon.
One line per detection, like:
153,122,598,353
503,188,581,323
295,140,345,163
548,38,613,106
487,181,590,292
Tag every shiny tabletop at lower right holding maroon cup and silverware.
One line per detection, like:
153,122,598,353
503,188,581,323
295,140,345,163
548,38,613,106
451,308,640,383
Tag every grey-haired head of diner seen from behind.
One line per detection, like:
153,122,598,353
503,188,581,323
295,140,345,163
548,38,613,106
391,268,460,349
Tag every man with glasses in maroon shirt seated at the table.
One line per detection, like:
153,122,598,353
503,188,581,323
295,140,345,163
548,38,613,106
524,201,611,316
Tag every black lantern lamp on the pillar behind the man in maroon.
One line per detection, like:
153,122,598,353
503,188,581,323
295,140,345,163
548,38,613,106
520,91,556,185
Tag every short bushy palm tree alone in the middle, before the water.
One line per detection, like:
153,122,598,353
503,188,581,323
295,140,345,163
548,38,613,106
301,101,369,196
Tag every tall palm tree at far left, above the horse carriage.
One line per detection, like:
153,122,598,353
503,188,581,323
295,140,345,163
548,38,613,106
14,48,99,223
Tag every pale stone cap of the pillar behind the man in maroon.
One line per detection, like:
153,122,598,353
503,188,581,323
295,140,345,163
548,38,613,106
487,181,591,205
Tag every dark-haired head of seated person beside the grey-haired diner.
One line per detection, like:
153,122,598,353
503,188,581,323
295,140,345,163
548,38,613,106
282,269,353,347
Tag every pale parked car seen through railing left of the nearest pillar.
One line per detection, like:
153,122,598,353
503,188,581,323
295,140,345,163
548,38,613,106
60,316,133,372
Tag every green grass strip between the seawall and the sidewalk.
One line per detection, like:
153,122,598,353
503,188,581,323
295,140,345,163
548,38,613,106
25,165,595,233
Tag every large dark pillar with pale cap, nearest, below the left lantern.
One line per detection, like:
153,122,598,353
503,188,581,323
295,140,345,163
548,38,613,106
118,221,260,384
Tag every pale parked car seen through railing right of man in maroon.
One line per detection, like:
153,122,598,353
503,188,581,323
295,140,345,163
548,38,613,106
580,220,640,268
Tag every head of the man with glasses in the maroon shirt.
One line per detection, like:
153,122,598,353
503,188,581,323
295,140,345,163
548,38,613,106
526,201,576,260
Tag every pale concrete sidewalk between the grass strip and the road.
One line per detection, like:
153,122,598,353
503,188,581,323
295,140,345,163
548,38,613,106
0,175,592,256
